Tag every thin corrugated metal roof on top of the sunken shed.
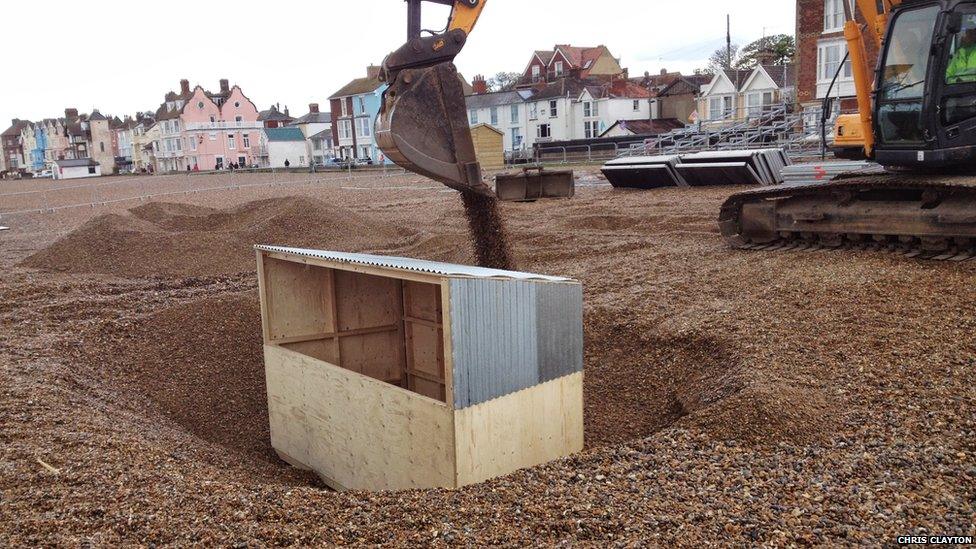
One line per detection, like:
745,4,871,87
254,246,576,283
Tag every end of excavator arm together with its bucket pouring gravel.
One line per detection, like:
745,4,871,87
376,0,493,196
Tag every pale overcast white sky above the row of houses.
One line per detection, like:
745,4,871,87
0,0,795,128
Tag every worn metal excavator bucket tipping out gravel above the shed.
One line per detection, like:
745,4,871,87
376,63,492,196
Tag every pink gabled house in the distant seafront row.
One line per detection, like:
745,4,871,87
180,80,262,171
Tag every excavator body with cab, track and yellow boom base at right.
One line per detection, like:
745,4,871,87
719,0,976,261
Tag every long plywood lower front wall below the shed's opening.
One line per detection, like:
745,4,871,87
265,345,456,491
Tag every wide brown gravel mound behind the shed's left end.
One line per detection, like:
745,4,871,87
21,197,398,278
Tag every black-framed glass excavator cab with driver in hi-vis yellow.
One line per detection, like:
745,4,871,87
874,0,976,168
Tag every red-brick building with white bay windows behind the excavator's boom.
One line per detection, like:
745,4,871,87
796,0,878,120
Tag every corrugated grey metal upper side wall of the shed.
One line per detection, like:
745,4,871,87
451,279,583,409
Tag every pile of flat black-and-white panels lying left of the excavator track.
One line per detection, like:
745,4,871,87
603,149,790,189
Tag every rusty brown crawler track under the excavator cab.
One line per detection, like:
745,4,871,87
719,173,976,262
